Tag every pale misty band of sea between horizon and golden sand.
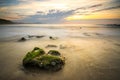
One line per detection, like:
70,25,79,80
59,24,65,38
0,24,120,40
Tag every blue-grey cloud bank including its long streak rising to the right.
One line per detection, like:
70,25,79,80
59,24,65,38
16,4,101,23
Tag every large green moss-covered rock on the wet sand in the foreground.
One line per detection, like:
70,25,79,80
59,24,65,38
23,47,65,71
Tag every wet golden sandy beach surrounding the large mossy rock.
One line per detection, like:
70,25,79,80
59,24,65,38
0,24,120,80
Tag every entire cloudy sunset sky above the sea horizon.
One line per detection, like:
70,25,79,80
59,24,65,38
0,0,120,23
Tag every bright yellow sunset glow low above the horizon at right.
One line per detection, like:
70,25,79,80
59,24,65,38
64,9,120,21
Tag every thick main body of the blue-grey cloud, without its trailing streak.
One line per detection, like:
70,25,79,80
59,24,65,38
17,10,73,23
